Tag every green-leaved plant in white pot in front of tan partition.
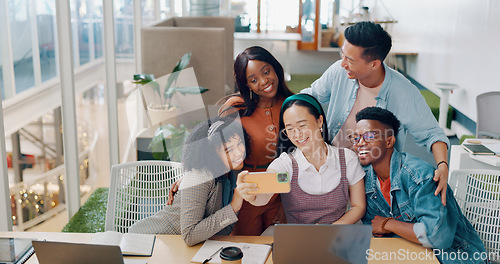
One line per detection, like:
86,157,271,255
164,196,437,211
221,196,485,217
133,52,208,125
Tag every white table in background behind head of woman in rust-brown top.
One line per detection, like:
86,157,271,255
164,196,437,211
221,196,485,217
234,32,302,81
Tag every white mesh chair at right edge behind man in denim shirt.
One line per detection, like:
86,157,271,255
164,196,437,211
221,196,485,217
450,170,500,256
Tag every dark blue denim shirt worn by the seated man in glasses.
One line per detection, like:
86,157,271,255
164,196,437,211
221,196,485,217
362,149,486,263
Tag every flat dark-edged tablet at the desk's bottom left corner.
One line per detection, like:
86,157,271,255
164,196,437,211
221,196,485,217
0,237,34,264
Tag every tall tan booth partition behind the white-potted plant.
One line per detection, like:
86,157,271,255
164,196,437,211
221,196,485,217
141,17,234,105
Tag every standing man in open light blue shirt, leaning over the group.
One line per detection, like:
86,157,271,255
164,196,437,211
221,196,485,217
302,21,449,204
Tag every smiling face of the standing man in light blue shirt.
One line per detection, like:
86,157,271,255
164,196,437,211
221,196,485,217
340,40,375,80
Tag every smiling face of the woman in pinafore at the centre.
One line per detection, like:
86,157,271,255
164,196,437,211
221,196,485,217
283,104,324,153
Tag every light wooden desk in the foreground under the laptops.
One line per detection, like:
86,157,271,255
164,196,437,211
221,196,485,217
0,232,439,264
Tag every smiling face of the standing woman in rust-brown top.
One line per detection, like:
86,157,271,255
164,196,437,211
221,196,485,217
246,60,278,99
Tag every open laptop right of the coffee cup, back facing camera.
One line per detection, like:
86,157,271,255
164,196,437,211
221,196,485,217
273,224,372,264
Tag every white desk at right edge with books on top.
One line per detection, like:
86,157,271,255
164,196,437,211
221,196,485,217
449,139,500,172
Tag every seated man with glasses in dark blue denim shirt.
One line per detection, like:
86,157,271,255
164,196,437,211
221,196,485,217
349,107,487,263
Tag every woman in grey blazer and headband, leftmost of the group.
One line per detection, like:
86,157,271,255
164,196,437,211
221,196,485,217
129,117,248,246
